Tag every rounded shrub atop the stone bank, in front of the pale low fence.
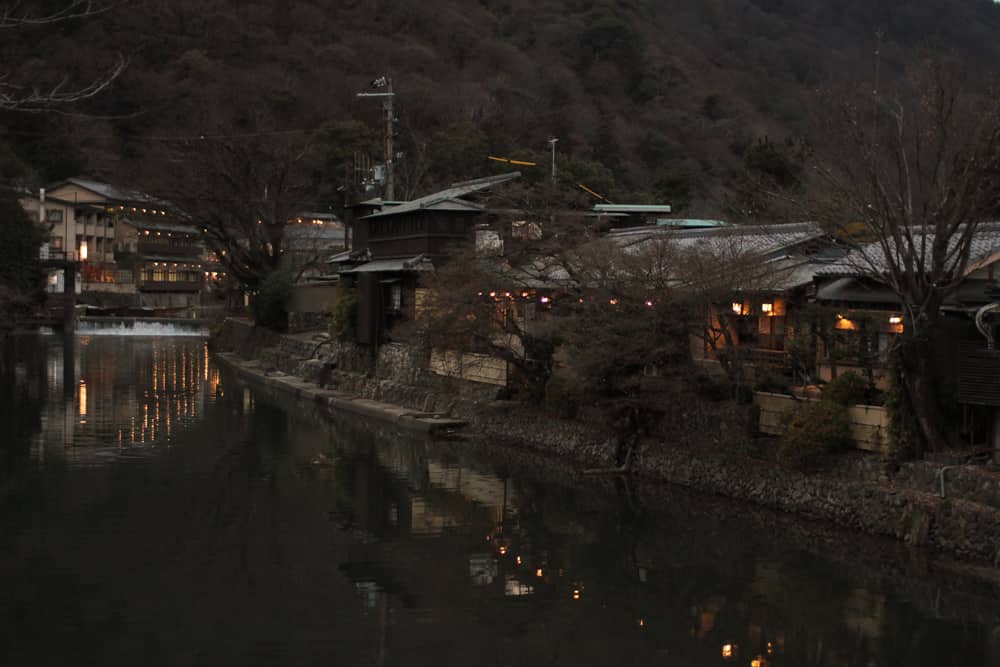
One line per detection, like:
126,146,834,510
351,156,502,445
778,400,851,471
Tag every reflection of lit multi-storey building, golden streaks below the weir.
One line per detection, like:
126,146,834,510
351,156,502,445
32,336,222,463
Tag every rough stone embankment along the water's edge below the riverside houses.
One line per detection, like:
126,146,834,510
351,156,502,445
214,320,1000,567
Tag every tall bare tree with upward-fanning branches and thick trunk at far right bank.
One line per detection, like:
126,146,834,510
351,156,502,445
810,62,1000,449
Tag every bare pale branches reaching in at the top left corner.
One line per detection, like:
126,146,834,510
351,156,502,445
0,0,128,112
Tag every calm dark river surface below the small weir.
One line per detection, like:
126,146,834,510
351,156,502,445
0,336,1000,667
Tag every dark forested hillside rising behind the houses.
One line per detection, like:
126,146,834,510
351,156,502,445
0,0,1000,213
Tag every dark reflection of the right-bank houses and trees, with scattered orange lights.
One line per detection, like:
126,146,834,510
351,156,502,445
313,414,1000,667
